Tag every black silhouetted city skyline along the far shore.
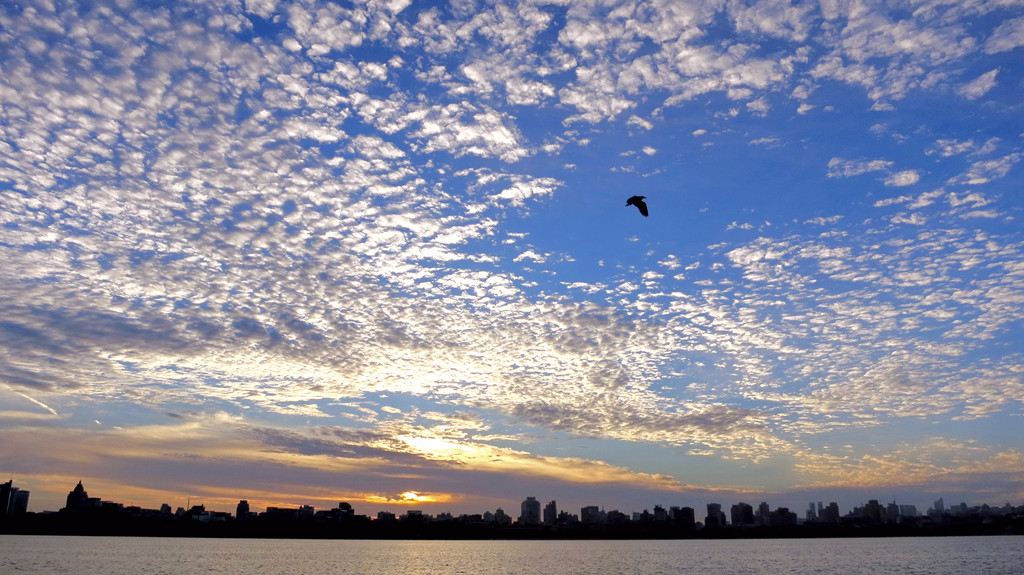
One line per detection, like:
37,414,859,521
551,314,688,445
6,482,1024,540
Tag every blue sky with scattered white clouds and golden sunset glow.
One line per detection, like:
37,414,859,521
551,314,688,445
0,0,1024,519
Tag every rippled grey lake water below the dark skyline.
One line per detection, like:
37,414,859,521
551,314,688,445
0,535,1024,575
